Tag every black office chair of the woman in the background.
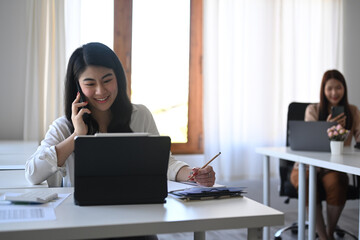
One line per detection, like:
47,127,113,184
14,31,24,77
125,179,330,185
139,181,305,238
274,102,359,240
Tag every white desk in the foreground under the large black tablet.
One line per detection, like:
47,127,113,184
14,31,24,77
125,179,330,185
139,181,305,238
0,188,284,240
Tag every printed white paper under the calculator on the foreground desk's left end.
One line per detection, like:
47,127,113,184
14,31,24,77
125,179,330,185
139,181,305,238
0,193,70,223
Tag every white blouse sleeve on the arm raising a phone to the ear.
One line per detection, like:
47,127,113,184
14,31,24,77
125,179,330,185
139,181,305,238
25,117,70,187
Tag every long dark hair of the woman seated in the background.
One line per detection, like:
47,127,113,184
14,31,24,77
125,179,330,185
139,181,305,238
319,69,352,129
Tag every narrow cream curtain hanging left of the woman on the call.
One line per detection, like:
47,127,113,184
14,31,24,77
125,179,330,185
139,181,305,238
24,0,65,140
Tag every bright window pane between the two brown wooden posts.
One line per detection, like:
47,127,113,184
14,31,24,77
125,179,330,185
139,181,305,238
131,0,190,143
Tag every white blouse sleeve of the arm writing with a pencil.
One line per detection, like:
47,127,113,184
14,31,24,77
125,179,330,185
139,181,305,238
130,104,188,181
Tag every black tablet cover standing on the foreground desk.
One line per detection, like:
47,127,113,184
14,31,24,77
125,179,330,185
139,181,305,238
74,136,171,205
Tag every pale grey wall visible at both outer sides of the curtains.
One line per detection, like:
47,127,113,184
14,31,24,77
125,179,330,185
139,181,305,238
0,0,360,140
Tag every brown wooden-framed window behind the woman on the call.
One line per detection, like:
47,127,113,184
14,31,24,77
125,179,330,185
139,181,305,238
114,0,203,153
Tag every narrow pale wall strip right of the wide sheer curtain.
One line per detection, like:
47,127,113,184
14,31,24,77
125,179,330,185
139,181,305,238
343,0,360,108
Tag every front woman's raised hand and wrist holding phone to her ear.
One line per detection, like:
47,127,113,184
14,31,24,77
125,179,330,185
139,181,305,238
71,93,91,135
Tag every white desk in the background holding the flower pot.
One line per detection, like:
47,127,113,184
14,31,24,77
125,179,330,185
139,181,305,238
256,147,360,239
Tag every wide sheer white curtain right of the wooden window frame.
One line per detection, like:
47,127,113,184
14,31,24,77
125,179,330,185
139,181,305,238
204,0,342,180
